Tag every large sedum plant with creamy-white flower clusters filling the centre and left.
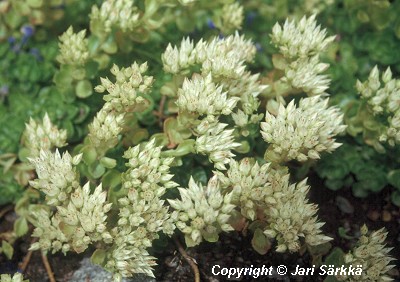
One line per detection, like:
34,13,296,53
0,3,396,281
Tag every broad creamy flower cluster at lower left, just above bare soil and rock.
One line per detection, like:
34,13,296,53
31,183,112,253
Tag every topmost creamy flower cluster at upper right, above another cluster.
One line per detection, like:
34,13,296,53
271,15,336,59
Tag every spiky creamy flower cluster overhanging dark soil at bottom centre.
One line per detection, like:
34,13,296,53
168,176,235,247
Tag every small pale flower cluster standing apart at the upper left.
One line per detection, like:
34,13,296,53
57,26,89,65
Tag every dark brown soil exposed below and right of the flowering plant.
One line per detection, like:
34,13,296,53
0,173,400,282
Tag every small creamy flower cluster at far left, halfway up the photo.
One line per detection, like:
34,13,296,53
23,113,67,158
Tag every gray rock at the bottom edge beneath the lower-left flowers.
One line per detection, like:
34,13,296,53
69,258,156,282
